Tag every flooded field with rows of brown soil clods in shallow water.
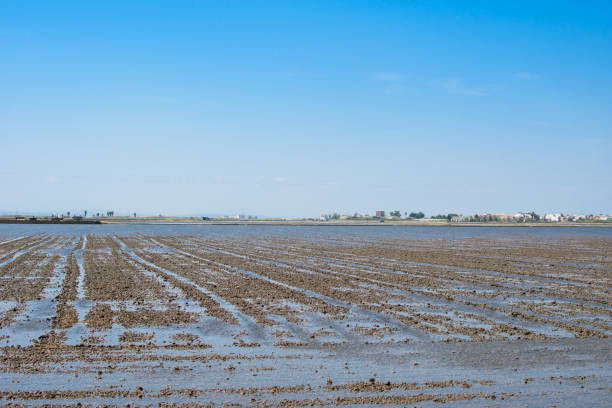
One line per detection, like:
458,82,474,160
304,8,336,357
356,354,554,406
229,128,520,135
0,226,612,407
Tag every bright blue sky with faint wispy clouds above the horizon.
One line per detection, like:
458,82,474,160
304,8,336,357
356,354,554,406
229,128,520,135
0,0,612,217
